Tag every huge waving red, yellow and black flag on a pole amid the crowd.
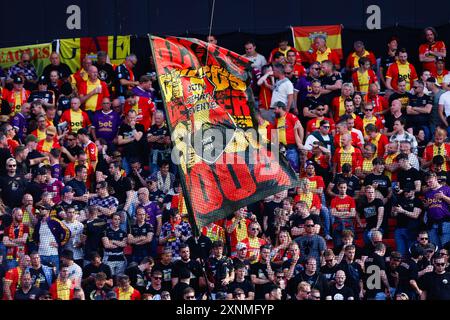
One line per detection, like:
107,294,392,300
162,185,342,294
150,36,297,229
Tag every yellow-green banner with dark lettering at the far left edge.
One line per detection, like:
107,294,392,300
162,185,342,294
0,43,52,75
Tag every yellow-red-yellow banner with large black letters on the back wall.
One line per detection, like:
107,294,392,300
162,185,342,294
58,36,130,72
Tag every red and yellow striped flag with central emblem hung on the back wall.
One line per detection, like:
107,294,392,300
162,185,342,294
291,25,343,61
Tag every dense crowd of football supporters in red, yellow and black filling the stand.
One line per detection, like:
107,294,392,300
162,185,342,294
0,27,450,300
